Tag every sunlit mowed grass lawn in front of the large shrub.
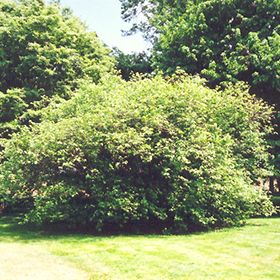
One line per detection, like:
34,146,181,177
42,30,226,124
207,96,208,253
0,218,280,280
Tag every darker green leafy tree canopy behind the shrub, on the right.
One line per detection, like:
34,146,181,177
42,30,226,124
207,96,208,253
121,0,280,96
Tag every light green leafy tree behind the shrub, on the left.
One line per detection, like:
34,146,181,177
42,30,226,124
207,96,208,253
0,0,113,142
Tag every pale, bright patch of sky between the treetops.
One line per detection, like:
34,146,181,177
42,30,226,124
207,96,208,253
60,0,148,53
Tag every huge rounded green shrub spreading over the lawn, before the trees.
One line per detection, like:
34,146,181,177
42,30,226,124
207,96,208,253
0,76,272,231
